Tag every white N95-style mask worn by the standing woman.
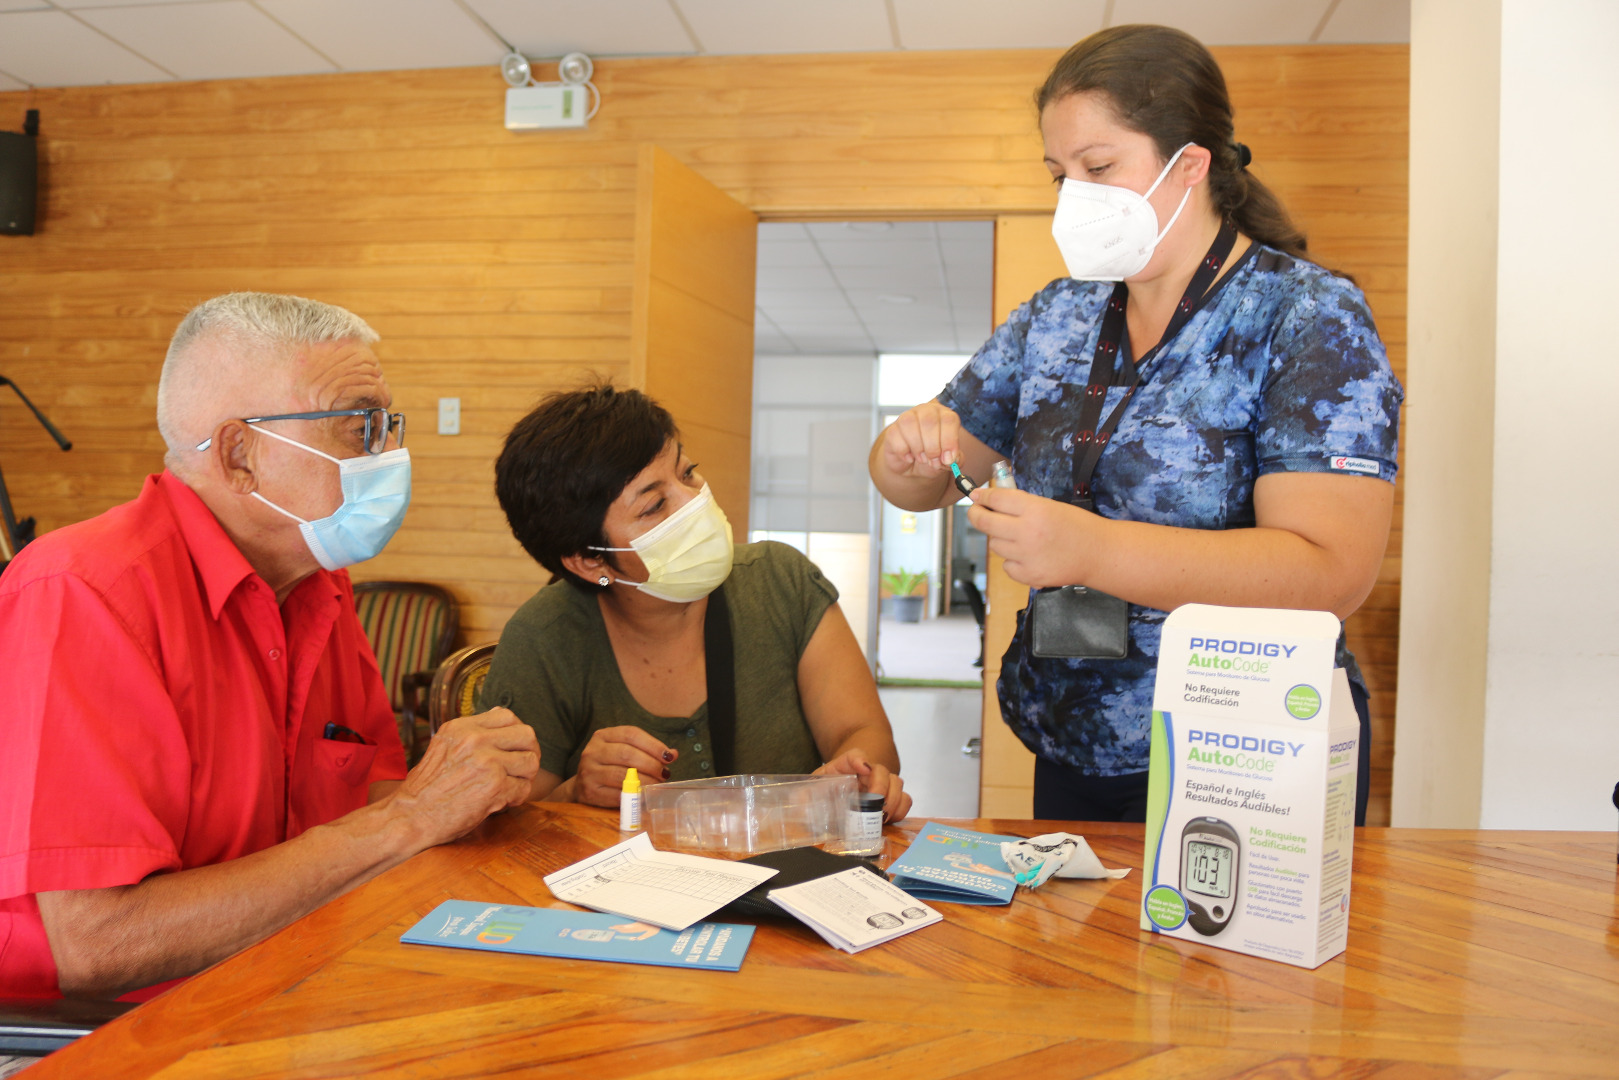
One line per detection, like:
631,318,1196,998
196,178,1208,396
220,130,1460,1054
1051,142,1192,282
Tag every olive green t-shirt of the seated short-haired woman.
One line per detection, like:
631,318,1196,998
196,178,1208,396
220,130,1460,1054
482,541,837,780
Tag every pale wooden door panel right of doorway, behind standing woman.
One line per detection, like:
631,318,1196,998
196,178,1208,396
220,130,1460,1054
978,214,1067,818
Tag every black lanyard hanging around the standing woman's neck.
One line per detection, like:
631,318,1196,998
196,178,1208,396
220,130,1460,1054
1072,220,1237,510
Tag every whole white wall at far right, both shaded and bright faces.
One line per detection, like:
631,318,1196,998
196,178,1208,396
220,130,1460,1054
1392,0,1619,829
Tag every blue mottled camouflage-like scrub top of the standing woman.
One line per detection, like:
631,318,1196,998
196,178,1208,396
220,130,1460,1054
939,244,1404,776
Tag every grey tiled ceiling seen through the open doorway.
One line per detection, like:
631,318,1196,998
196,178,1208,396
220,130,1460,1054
753,222,994,355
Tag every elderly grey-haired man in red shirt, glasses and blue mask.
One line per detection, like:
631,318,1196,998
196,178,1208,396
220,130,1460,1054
0,293,539,1001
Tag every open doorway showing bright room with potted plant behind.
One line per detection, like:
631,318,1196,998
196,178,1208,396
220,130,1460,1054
748,222,994,816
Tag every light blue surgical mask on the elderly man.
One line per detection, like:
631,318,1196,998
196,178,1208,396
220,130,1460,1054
253,427,410,570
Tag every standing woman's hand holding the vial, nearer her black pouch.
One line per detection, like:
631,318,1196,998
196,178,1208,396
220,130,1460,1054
967,487,1096,589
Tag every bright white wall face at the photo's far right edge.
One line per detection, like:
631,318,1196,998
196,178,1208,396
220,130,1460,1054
1480,0,1619,829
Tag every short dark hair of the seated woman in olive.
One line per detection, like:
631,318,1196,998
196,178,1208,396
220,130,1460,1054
495,382,680,589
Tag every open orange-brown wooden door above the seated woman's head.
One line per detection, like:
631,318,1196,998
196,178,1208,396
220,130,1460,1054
630,144,759,542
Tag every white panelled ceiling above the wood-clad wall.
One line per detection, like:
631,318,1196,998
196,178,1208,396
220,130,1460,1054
0,0,1410,91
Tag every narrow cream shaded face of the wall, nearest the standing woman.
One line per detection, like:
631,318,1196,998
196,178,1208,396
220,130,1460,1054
1389,0,1501,829
